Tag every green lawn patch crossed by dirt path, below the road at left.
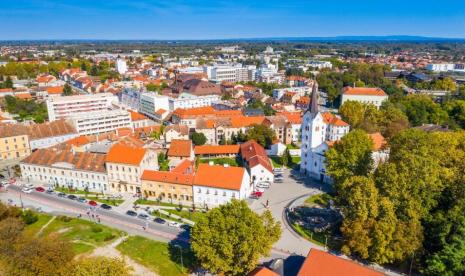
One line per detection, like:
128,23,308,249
35,216,124,254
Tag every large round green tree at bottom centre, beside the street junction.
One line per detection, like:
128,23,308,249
191,200,281,275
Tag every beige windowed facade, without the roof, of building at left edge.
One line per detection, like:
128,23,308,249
0,135,31,160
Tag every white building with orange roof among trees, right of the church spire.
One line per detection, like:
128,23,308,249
341,86,388,108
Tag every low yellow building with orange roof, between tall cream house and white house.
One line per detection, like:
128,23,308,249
141,160,194,205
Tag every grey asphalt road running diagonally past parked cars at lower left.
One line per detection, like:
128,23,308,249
0,185,189,243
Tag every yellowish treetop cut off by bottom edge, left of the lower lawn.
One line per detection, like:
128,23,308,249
71,257,131,276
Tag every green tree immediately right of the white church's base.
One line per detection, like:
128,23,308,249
325,130,373,185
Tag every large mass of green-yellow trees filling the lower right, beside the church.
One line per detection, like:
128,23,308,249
326,129,465,275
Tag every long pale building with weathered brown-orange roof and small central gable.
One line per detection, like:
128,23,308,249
20,148,109,193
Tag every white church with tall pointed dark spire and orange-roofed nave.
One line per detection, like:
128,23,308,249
300,82,350,183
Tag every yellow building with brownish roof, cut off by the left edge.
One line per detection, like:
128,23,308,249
0,124,31,161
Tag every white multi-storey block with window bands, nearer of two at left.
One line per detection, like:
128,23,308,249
69,109,132,135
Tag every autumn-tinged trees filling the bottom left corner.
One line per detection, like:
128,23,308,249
0,203,130,276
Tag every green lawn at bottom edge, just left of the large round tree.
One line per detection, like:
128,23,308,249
116,236,189,275
